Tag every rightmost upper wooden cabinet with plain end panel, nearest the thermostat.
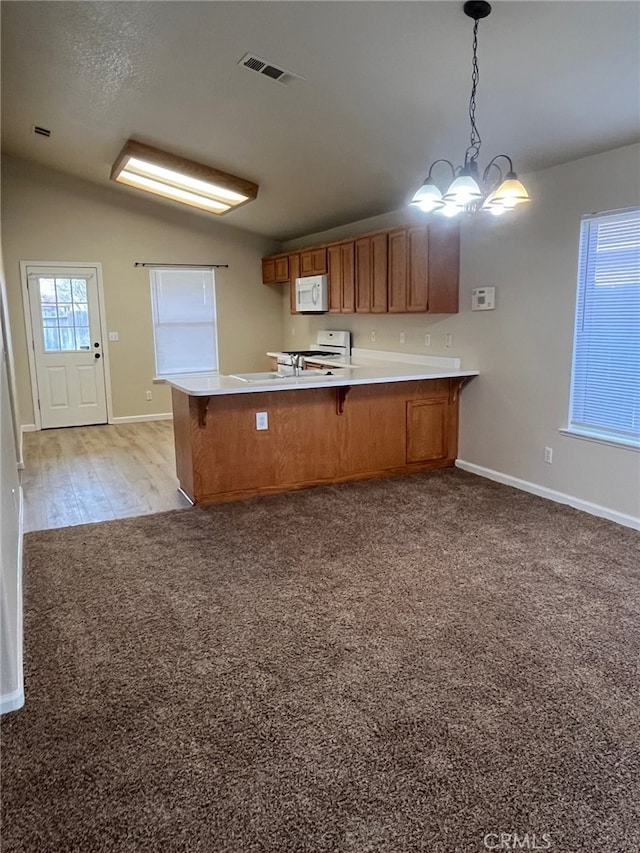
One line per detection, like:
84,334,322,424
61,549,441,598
388,223,460,314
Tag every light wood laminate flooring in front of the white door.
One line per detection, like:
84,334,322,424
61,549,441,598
22,420,189,531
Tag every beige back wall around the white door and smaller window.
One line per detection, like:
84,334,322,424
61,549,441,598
2,157,282,424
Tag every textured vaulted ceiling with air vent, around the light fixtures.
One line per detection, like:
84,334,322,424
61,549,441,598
1,0,640,239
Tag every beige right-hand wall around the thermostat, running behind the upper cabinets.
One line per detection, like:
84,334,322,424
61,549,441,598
283,145,640,518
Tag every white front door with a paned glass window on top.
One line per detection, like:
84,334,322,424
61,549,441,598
26,266,107,429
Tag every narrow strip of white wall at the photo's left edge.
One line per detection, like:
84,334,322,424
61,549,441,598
0,243,24,714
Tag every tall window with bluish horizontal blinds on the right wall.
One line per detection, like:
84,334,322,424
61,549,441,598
569,208,640,447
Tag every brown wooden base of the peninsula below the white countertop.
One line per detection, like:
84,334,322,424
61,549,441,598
172,378,460,503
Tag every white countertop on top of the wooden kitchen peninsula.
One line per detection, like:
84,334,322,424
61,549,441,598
166,349,479,397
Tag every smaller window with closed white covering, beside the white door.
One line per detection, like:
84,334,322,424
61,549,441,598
151,268,218,377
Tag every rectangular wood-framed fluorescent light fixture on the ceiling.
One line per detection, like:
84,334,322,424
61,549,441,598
111,139,258,215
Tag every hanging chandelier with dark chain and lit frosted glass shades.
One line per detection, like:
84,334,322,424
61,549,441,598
410,0,530,216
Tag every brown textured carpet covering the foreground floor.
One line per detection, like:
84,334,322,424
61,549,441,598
2,470,640,853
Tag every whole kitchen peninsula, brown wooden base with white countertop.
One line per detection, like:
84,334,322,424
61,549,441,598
169,350,478,504
